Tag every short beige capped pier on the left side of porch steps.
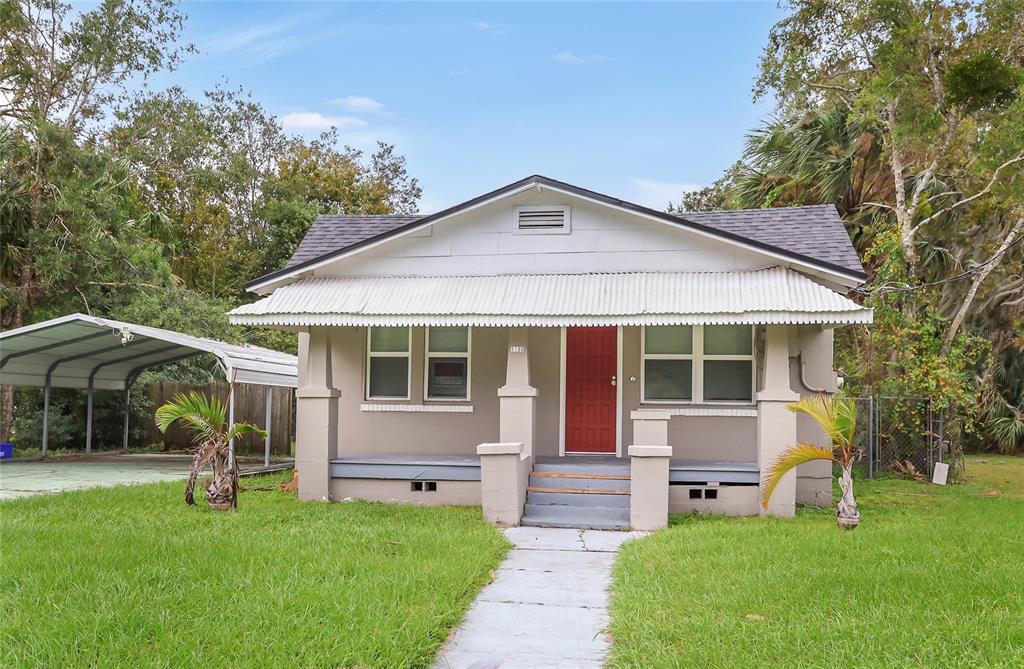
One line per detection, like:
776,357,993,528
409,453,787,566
477,442,529,528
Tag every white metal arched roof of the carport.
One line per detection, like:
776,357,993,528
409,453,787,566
0,313,298,390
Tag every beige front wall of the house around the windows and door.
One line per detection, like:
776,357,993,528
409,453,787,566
300,327,835,479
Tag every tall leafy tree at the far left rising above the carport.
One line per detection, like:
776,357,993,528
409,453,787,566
0,0,190,438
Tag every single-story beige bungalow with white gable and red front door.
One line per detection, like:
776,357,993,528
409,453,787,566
229,176,871,529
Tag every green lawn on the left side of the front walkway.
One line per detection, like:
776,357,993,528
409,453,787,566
0,475,508,667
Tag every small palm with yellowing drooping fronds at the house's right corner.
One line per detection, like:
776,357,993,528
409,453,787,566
761,394,860,530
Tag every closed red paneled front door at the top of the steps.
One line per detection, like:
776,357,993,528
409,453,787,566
565,327,617,453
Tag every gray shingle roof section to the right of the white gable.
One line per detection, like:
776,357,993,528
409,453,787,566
678,205,864,273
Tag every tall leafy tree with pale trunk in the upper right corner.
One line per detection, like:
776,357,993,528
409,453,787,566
755,0,1024,281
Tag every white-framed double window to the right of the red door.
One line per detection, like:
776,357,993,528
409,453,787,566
641,325,754,403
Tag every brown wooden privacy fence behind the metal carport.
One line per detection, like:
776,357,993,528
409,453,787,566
146,381,295,456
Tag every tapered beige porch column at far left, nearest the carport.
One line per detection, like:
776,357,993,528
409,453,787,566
295,328,341,500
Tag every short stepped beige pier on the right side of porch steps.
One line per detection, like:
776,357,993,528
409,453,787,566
629,411,672,530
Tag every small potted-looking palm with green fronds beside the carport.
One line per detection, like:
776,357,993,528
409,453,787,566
157,390,266,510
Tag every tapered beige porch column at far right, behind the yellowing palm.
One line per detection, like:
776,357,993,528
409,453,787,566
757,325,800,517
